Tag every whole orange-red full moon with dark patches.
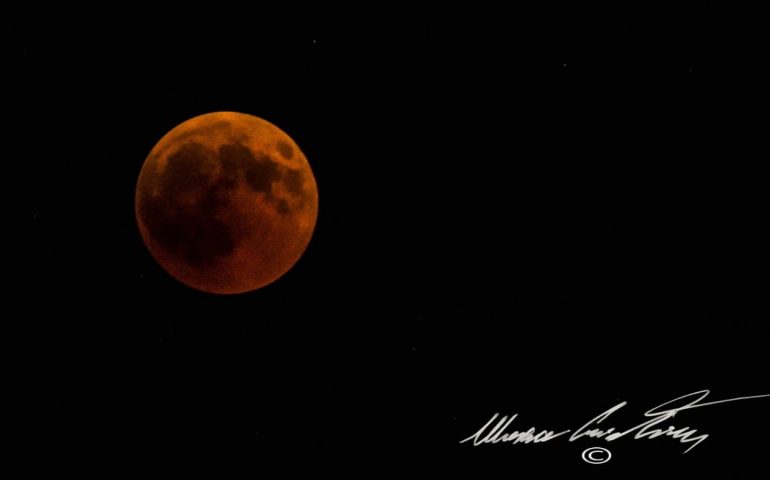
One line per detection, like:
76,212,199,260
135,112,318,294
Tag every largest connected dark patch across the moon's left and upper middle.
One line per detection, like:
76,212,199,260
138,143,304,270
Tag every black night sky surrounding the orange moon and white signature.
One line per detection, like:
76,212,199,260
21,4,770,478
